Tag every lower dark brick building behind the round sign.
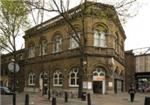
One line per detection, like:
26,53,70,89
0,49,24,92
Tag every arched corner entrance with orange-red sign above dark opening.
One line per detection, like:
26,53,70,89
93,67,106,94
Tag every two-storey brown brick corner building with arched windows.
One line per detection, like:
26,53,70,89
1,2,126,94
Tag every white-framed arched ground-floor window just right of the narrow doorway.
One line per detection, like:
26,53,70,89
53,71,63,86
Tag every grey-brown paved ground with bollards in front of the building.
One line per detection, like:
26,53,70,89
0,93,150,105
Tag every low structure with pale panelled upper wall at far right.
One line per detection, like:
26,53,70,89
126,47,150,92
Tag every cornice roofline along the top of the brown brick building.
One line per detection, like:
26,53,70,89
24,1,126,38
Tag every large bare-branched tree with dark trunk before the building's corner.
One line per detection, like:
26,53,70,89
26,0,141,98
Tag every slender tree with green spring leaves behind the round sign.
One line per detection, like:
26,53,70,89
0,0,28,93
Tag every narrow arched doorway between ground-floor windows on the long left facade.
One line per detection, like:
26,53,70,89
39,72,48,94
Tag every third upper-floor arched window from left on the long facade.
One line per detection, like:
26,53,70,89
53,35,62,53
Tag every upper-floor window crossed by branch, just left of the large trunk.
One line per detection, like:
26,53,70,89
69,32,80,49
